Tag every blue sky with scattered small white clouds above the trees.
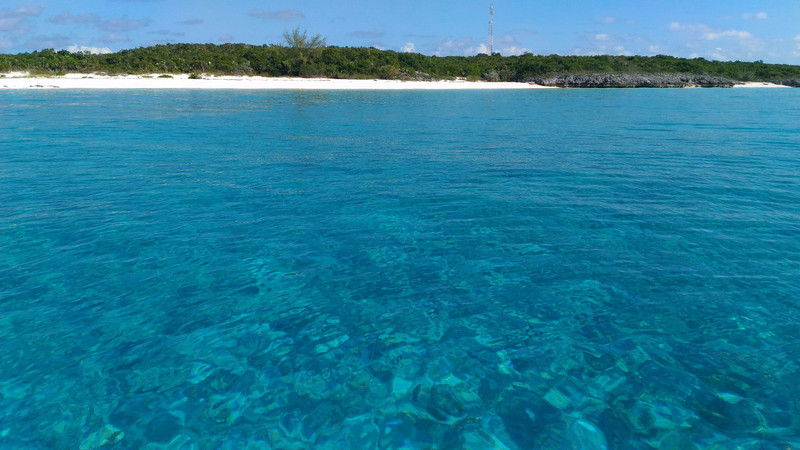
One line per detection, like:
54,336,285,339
0,0,800,64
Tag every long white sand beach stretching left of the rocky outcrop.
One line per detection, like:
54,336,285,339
0,72,553,90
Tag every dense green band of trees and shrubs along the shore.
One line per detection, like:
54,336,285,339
0,44,800,83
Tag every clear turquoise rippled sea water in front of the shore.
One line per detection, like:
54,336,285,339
0,90,800,448
